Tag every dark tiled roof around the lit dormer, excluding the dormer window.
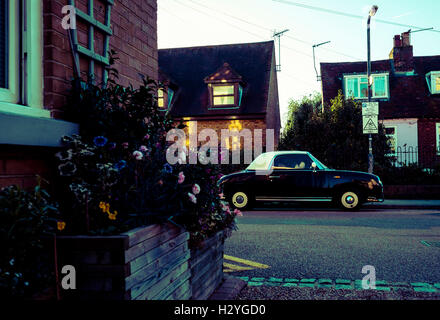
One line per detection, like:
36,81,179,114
159,41,275,117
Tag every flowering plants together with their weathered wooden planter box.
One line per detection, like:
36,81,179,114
0,69,241,300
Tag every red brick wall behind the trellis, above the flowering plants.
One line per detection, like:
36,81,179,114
43,0,158,118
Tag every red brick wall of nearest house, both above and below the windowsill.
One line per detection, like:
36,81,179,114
0,0,158,188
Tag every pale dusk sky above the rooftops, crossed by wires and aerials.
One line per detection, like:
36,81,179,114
158,0,440,123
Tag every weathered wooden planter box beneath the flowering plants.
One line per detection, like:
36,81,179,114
57,224,224,300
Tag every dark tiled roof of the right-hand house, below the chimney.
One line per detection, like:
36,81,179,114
321,56,440,119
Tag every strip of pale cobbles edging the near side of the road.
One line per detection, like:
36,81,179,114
232,277,440,294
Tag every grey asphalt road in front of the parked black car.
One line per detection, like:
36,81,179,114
225,207,440,282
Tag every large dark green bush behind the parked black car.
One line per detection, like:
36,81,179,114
279,92,391,171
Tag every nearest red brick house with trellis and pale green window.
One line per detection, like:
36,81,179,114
0,0,158,188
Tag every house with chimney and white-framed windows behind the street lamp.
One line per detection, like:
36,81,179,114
321,32,440,167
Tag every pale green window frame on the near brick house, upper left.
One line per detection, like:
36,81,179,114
0,0,46,118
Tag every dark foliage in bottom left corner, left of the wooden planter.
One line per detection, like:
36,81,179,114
0,181,59,298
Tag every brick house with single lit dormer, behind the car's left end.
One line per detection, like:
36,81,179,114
159,41,280,154
